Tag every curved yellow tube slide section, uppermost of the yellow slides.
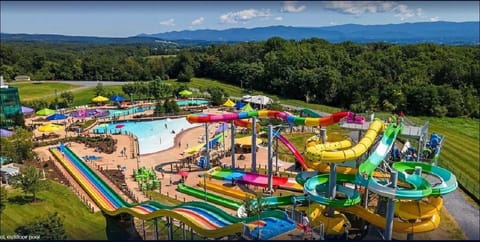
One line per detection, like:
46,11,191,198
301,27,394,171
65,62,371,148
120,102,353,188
306,120,385,163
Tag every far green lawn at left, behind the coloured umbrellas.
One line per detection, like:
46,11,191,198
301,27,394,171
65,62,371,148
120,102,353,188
8,82,80,101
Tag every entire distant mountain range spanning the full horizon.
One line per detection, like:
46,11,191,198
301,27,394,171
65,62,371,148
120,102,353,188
0,21,480,47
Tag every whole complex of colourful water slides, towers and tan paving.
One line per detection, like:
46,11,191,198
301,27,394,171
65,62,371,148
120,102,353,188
42,101,458,239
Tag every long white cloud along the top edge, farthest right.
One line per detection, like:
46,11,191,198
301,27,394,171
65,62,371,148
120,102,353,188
324,1,423,20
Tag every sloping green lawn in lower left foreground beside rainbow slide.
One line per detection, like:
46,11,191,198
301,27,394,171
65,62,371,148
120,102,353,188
1,181,126,240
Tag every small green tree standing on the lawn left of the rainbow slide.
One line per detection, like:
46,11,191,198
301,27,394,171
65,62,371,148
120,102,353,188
12,166,47,202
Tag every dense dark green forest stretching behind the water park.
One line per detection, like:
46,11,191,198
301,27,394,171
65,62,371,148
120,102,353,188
0,37,480,118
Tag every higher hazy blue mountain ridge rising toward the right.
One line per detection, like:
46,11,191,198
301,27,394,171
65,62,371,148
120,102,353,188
138,21,480,44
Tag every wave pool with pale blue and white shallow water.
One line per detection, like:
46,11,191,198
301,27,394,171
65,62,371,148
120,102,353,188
94,118,202,155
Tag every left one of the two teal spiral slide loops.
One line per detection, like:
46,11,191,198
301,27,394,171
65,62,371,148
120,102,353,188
303,173,361,207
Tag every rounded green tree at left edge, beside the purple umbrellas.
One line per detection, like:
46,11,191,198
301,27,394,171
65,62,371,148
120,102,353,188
0,128,34,163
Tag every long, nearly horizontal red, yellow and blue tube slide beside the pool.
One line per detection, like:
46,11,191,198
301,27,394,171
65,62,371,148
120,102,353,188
187,110,349,126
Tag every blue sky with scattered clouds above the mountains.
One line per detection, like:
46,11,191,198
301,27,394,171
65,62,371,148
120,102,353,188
0,0,480,37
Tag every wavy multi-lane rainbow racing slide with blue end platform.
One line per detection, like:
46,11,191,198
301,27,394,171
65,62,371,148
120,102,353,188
50,146,296,239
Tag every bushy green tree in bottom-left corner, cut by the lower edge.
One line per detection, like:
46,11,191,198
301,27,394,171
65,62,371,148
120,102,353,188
15,212,67,240
